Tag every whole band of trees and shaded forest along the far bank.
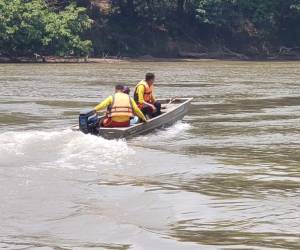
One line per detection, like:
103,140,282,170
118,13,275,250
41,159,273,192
0,0,300,59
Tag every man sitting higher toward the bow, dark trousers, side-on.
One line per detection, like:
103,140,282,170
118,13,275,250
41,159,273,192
134,73,161,118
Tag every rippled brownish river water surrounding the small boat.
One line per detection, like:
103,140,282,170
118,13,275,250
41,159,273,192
0,61,300,250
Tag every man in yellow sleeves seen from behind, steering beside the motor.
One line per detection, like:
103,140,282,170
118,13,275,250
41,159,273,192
94,85,146,128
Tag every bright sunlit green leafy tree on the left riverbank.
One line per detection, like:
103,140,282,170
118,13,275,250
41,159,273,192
0,0,92,56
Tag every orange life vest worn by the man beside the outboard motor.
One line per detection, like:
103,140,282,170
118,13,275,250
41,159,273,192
107,93,133,119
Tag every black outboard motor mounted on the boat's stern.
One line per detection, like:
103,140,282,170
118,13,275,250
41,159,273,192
79,109,99,134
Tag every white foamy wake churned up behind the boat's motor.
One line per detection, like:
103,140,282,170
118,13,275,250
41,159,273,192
0,129,134,169
